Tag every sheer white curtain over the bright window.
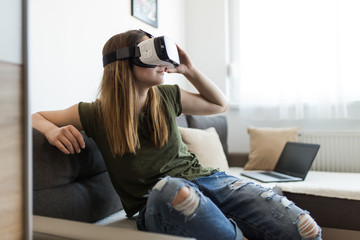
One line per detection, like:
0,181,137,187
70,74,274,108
229,0,360,119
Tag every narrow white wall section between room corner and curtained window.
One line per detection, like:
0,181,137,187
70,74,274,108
185,0,228,94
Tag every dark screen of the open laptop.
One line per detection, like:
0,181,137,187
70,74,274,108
274,142,320,179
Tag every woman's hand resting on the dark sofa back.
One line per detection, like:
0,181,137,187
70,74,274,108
46,125,85,154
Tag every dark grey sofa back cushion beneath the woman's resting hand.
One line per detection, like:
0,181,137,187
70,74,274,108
33,129,122,222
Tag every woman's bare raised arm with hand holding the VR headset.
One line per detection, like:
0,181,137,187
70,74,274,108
166,47,230,115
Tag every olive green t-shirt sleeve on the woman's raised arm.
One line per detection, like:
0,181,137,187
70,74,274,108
158,84,182,116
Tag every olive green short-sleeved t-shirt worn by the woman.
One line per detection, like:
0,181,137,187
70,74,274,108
79,85,214,217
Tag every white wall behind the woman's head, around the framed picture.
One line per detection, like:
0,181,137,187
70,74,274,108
28,0,186,113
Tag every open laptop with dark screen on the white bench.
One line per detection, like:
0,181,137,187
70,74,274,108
241,142,320,182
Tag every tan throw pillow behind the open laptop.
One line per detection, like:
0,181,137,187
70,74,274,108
244,127,298,170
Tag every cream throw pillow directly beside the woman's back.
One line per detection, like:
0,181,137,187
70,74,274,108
178,127,229,171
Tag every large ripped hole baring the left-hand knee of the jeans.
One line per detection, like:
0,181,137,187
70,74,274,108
172,186,200,216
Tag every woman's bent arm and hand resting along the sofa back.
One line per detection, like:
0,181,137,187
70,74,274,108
32,104,85,154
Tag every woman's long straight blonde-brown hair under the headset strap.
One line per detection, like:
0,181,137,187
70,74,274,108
99,30,168,156
